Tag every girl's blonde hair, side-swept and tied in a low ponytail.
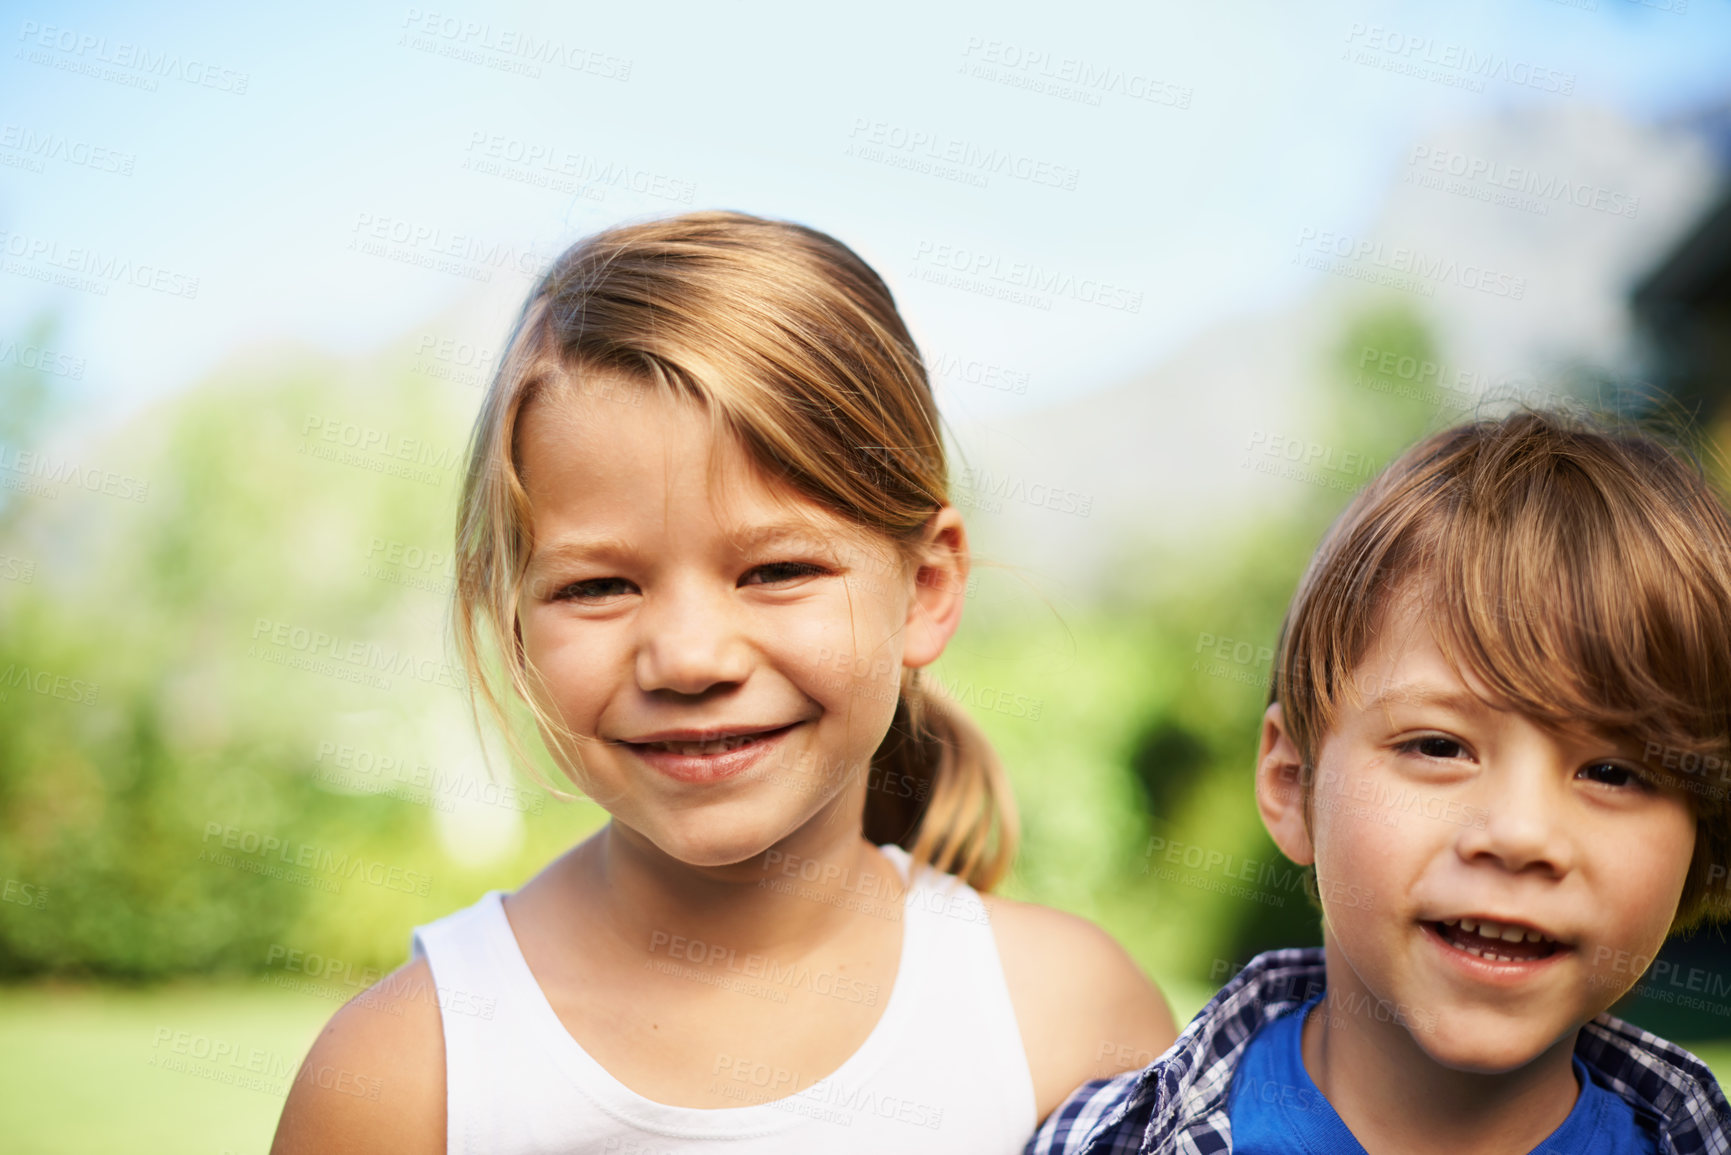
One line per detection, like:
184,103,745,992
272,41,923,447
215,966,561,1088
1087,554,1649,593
452,213,1018,890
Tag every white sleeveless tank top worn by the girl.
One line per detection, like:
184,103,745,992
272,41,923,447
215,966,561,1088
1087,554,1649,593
410,847,1035,1155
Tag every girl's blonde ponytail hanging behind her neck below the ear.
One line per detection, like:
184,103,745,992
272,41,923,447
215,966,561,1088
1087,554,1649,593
864,674,1021,890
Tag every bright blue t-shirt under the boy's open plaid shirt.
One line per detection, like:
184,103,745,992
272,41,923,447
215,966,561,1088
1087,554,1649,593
1226,994,1655,1155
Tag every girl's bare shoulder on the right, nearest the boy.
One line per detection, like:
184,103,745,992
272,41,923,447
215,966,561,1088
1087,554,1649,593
981,895,1179,1119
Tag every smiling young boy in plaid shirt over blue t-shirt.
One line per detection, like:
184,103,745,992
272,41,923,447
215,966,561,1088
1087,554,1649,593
1028,412,1731,1155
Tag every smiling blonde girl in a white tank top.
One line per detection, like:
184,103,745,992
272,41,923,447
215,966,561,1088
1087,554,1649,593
273,213,1175,1155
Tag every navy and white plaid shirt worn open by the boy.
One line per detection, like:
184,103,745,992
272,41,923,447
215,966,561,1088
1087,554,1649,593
1025,947,1731,1155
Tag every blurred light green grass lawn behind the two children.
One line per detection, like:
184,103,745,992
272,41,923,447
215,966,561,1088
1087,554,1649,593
0,982,1731,1155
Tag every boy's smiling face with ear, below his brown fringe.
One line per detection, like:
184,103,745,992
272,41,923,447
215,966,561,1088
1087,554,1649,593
1257,599,1695,1072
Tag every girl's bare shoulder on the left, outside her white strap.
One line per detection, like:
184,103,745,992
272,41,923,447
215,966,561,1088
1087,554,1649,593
270,958,445,1155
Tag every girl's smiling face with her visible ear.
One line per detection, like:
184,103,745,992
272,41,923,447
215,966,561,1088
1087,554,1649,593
518,377,966,866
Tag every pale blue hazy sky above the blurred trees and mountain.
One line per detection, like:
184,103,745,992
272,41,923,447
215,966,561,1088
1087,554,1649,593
0,0,1731,432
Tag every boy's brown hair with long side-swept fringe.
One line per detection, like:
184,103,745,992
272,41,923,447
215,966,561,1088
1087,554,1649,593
1269,410,1731,930
